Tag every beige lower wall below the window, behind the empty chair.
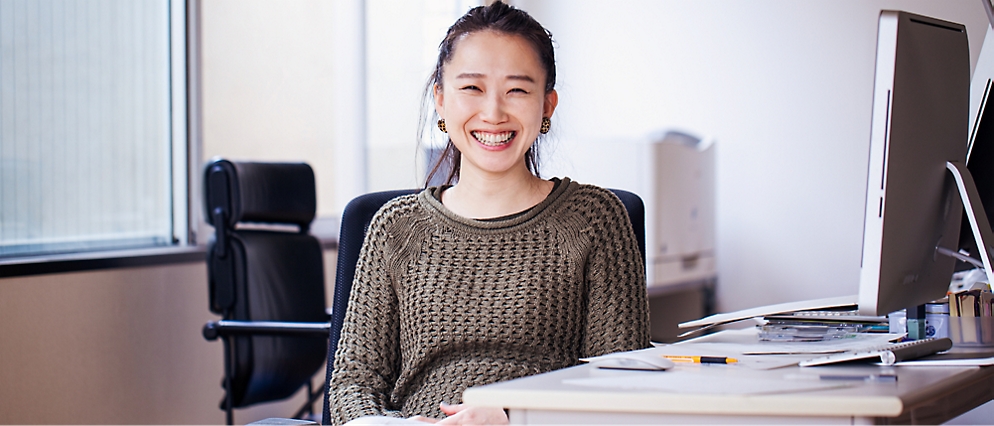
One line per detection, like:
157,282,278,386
0,251,337,424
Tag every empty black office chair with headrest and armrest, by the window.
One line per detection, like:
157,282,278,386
203,159,330,424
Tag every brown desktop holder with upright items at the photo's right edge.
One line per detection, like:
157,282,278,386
949,289,994,346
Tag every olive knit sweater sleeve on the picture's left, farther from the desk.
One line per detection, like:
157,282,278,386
328,212,401,424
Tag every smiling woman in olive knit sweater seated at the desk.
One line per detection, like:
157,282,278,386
329,2,649,424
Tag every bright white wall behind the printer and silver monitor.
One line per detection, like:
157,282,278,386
515,0,988,311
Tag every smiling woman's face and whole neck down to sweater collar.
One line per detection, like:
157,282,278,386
434,30,558,217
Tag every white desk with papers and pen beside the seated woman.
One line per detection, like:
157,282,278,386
463,336,994,424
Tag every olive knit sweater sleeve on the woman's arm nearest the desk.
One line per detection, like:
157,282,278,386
582,190,650,357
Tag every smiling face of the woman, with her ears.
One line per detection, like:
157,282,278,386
435,31,558,180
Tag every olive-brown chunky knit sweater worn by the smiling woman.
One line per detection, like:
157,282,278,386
328,178,649,424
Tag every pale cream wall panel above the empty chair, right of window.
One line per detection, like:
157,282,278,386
200,0,338,216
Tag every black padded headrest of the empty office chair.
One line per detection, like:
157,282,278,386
204,158,317,232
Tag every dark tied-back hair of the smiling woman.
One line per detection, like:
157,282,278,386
418,1,556,186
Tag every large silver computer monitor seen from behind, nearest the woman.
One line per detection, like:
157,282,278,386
858,11,970,315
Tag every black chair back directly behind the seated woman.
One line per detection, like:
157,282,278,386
321,189,645,424
